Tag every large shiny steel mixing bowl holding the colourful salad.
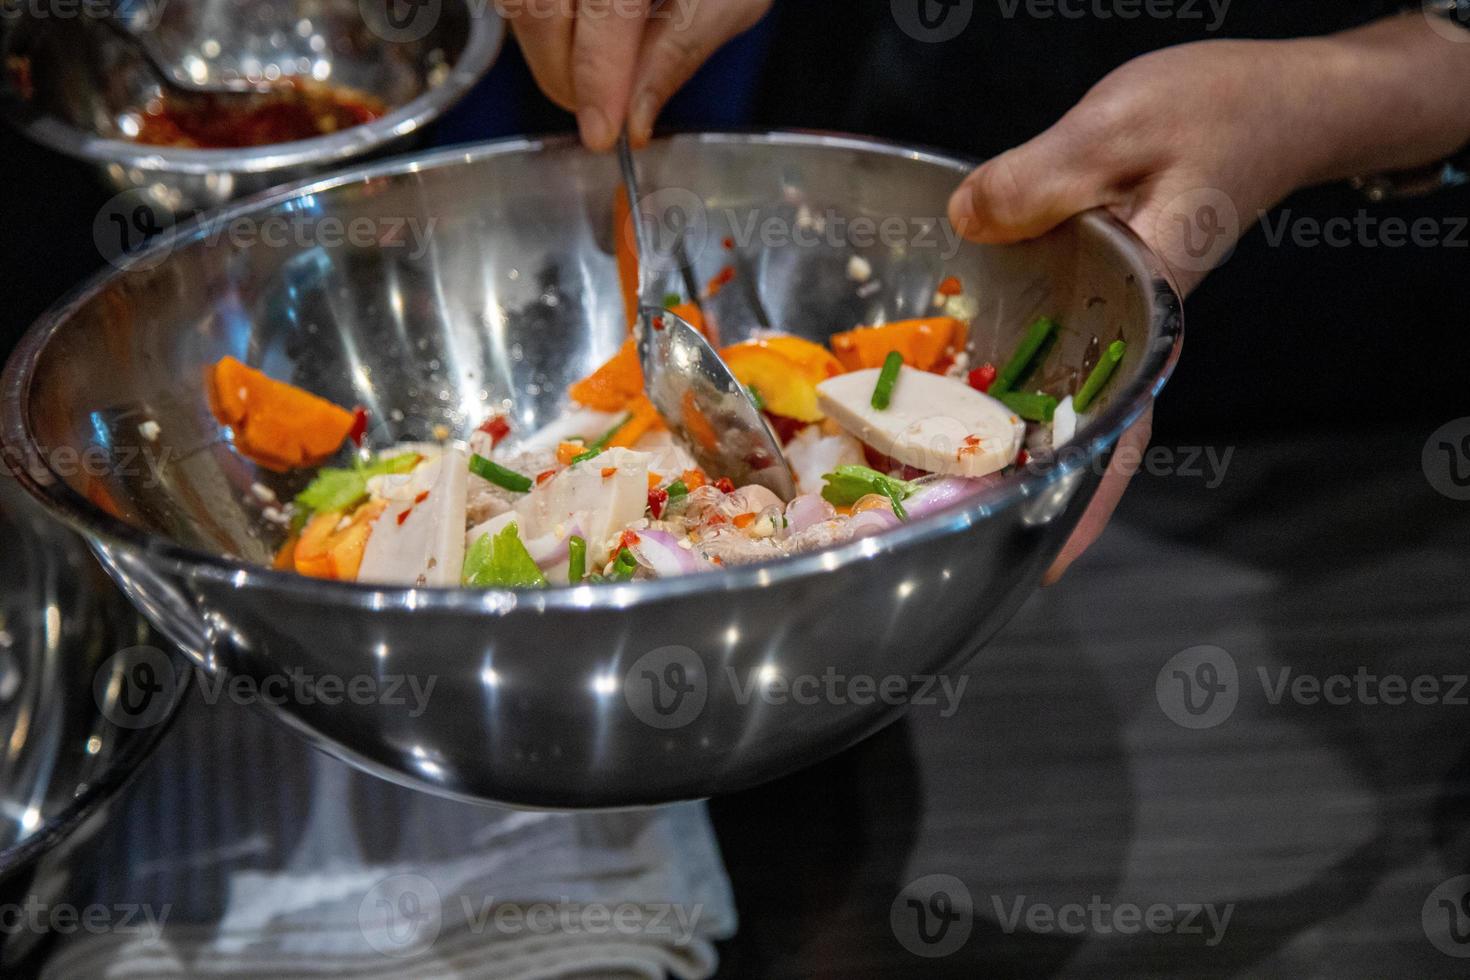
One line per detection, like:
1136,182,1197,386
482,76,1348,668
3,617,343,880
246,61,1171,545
0,134,1182,807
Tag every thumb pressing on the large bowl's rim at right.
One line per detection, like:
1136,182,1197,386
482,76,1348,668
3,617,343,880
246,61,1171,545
950,122,1119,244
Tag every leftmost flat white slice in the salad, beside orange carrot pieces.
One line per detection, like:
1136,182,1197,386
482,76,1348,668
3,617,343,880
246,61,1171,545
357,445,469,586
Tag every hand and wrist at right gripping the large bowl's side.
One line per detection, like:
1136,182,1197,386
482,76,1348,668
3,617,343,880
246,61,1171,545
950,18,1470,583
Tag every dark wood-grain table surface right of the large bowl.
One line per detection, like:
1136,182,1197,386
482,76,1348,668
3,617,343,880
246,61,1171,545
711,432,1470,977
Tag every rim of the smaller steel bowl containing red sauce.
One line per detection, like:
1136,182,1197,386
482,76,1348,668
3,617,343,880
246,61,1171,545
0,3,506,176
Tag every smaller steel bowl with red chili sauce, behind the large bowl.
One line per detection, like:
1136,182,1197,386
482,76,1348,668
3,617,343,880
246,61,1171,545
0,0,506,219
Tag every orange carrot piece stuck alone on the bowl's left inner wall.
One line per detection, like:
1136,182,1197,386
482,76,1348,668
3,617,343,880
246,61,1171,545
206,357,356,470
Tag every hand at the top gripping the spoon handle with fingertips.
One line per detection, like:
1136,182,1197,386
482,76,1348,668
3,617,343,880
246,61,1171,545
507,0,772,150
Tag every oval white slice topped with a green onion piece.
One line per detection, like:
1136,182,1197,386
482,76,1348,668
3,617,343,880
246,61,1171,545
817,367,1026,476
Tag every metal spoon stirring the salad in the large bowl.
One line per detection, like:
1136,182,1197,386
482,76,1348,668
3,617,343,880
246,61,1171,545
617,132,797,500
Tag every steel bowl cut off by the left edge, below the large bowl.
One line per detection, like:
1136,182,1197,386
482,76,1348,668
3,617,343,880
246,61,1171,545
0,479,190,976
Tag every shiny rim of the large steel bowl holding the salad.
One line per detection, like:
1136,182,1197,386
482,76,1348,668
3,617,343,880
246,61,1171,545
0,131,1183,614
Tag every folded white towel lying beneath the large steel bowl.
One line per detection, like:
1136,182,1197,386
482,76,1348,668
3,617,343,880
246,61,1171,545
41,688,735,980
